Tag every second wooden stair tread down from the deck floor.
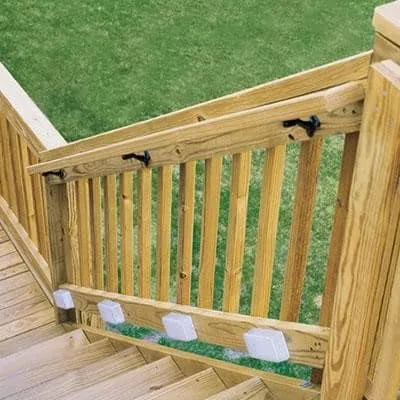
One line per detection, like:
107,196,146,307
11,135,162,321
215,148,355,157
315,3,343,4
8,347,146,400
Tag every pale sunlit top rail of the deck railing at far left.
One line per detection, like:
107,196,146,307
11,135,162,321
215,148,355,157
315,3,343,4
0,63,66,152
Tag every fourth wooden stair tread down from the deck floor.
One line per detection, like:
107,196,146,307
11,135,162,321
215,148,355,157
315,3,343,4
137,368,226,400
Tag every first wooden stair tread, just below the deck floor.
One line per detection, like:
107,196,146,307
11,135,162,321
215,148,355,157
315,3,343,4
0,329,89,379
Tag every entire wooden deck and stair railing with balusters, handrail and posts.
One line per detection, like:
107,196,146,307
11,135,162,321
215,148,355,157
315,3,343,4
0,3,400,400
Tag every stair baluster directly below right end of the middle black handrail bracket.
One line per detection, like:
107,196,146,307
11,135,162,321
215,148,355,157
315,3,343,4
138,168,152,297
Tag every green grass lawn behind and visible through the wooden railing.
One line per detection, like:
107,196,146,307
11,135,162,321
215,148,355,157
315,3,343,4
0,0,385,378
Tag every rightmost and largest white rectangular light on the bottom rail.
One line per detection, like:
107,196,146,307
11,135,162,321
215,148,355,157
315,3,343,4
243,328,289,362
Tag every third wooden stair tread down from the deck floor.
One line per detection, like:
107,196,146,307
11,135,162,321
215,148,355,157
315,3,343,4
62,356,184,400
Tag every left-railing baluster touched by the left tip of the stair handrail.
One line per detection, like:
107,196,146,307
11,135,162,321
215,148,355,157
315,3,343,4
20,142,39,246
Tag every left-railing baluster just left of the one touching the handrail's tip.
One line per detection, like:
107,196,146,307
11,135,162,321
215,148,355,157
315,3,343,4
9,126,28,231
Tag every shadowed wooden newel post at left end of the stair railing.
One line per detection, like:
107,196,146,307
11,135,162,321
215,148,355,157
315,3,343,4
45,176,80,322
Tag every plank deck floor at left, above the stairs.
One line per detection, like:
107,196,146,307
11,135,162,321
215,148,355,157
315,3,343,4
0,226,55,346
